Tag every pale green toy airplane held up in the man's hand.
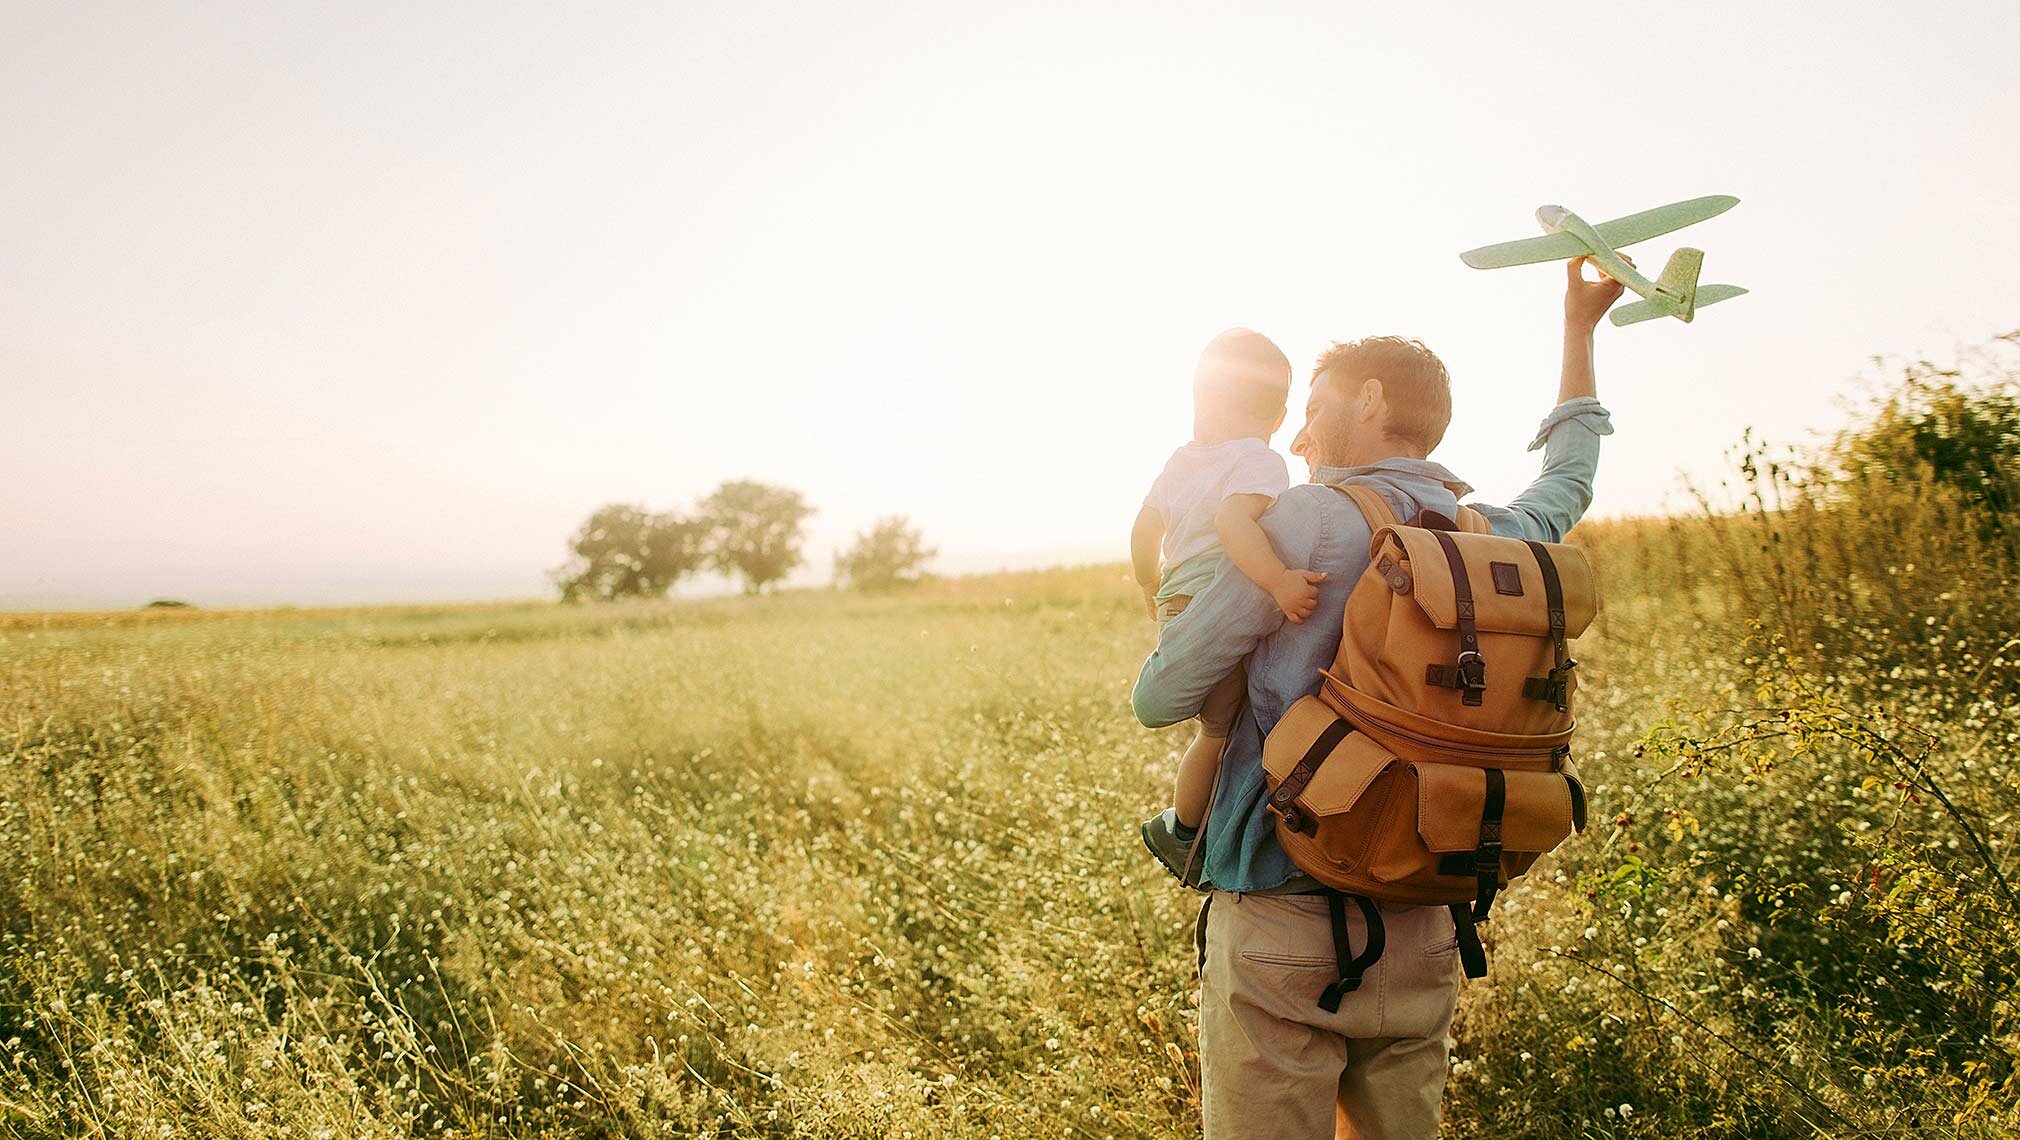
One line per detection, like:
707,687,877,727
1458,194,1745,325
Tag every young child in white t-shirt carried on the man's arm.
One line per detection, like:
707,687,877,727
1129,329,1325,885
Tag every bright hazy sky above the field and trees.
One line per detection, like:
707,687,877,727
0,0,2020,608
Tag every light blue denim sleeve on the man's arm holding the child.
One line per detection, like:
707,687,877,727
1129,493,1321,728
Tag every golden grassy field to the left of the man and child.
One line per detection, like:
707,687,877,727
0,570,1244,1136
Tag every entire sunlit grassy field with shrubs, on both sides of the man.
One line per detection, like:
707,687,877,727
0,349,2020,1138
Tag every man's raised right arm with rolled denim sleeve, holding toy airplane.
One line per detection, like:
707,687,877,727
1477,257,1620,542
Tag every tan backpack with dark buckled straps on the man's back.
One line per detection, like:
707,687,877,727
1263,483,1598,1009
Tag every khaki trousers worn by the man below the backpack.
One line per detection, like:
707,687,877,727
1200,891,1458,1140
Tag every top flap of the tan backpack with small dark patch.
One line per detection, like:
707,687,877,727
1374,526,1600,637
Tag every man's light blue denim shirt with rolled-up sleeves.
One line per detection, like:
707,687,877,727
1129,396,1614,891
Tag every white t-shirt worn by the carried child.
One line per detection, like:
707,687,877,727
1143,437,1291,596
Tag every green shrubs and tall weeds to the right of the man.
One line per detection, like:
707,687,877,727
1454,338,2020,1136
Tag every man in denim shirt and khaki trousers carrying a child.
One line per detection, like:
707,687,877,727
1131,259,1620,1140
